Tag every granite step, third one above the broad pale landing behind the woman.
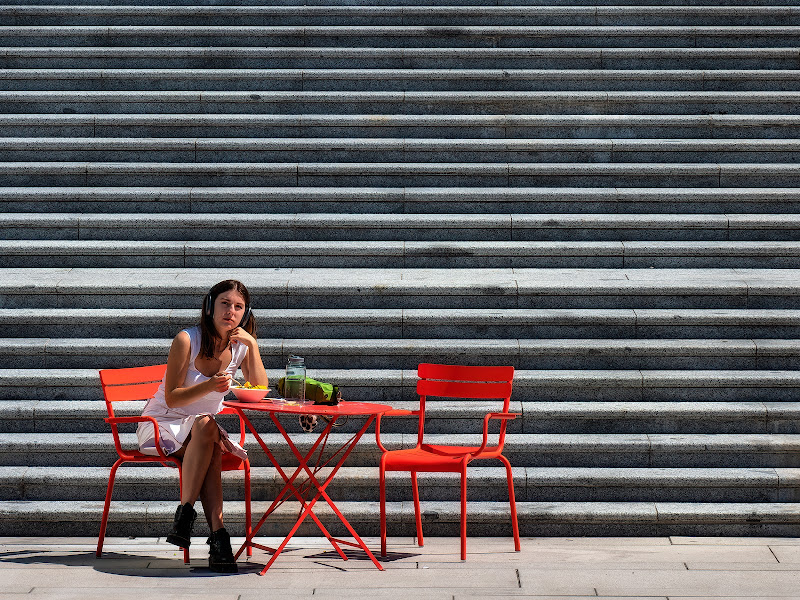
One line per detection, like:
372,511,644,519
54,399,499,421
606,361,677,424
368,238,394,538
0,190,800,216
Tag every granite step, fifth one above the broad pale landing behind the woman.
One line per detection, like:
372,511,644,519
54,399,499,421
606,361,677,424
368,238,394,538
0,137,800,164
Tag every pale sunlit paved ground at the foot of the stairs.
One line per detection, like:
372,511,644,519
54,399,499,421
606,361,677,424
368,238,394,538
0,537,800,600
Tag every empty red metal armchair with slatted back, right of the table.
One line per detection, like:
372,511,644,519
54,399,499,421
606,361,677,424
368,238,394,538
375,364,520,560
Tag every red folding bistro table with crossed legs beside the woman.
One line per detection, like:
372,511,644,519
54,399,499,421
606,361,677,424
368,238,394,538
223,399,392,575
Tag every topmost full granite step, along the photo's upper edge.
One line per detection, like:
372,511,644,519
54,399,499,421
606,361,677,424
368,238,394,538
6,5,800,27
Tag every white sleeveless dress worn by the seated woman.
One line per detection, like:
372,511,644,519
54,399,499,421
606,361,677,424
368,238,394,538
136,325,247,459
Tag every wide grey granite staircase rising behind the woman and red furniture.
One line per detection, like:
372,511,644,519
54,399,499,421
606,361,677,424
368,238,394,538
0,0,800,536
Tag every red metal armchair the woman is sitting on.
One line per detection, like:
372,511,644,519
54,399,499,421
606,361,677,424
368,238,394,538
97,365,253,564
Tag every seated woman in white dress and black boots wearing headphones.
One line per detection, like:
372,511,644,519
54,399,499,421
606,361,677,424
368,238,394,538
137,279,268,573
